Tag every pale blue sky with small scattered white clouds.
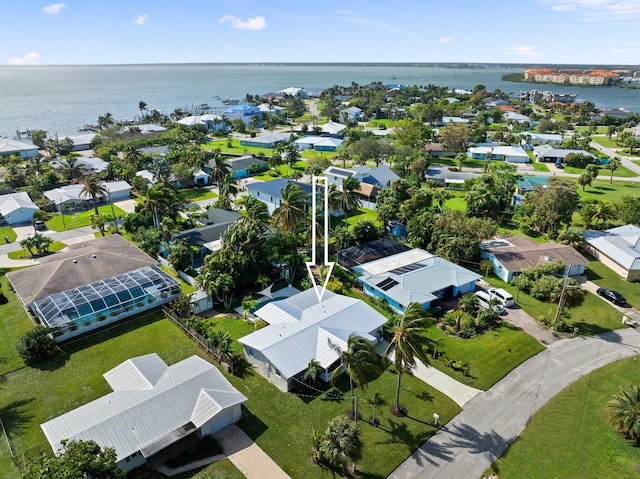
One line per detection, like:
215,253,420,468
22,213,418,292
0,0,640,65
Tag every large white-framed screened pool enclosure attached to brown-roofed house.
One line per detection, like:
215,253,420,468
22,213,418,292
30,266,181,340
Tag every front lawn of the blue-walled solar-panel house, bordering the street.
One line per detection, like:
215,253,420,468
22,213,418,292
427,323,544,390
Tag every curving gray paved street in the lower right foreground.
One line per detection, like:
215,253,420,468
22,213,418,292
389,328,640,479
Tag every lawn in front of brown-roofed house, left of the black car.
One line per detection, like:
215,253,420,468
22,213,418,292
488,275,626,335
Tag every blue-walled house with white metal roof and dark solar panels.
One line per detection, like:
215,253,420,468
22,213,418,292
353,249,480,313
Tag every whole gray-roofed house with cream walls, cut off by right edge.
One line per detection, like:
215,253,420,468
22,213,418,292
584,225,640,281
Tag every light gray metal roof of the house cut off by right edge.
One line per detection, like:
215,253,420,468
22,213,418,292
584,225,640,271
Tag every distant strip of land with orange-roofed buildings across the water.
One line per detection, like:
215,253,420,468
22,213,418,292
502,68,640,86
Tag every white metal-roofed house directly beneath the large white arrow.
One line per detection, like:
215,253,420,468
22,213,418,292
238,289,387,391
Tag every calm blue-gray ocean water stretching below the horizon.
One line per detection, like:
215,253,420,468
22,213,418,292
0,64,640,138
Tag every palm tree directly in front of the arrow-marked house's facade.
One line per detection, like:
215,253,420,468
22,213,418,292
331,335,377,421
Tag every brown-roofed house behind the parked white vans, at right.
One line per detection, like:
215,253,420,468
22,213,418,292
480,236,589,283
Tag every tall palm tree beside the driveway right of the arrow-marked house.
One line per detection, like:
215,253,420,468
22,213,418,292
384,303,429,415
